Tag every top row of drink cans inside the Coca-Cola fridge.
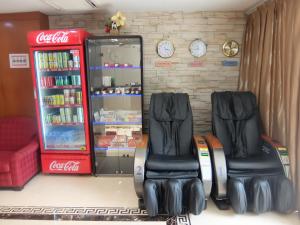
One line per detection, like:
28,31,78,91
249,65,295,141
37,50,80,71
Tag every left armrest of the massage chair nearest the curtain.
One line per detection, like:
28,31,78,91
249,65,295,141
205,133,227,200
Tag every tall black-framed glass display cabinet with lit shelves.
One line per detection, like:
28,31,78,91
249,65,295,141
86,36,143,175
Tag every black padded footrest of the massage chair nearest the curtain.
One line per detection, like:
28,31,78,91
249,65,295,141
228,176,295,214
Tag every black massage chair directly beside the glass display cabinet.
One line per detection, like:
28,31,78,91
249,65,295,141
134,93,212,216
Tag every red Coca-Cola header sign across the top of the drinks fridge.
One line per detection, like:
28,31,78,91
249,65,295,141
27,29,89,46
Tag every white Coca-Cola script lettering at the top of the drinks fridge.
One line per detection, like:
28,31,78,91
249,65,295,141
36,31,69,44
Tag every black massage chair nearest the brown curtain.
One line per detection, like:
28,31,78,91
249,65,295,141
205,92,295,214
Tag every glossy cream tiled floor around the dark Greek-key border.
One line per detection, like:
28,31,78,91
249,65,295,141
0,175,300,225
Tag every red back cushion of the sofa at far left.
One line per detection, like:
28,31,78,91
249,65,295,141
0,117,37,151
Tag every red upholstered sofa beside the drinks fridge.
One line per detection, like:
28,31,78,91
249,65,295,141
0,117,40,189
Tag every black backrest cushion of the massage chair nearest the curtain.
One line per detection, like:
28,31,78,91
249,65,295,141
212,92,262,157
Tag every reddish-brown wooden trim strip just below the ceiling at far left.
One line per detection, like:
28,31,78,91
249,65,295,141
0,12,48,21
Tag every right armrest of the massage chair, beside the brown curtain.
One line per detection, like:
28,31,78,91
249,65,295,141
262,134,290,178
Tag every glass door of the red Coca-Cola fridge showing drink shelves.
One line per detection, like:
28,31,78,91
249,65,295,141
34,49,86,151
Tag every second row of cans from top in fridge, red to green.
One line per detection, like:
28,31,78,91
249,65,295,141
41,75,81,88
